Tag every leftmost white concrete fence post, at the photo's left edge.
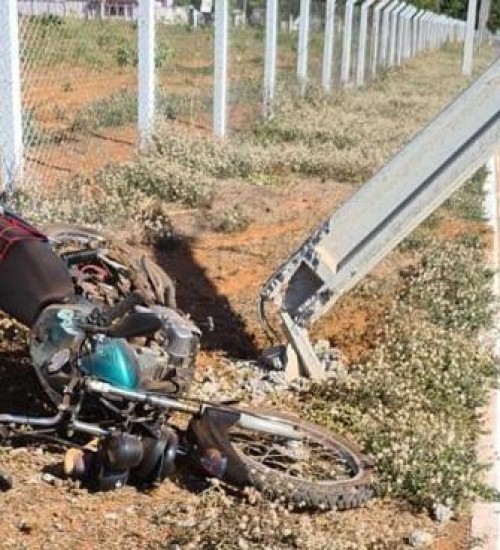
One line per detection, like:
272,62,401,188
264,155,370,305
0,0,23,192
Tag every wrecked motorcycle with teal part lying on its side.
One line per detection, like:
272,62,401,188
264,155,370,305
0,211,372,509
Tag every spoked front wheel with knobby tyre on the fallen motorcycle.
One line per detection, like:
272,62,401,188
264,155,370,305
193,408,373,510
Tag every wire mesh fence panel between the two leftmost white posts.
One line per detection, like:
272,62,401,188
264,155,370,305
18,0,137,190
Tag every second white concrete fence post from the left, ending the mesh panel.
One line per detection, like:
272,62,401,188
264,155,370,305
138,0,155,150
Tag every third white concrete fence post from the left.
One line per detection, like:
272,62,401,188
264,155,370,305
213,0,229,137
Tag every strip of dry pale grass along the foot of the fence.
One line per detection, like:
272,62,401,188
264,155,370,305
13,44,491,225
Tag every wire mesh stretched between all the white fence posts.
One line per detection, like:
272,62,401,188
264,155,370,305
0,0,468,195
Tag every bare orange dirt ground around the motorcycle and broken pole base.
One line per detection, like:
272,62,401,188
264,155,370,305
0,180,478,550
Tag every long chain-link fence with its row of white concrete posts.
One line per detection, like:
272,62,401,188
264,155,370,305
0,0,464,194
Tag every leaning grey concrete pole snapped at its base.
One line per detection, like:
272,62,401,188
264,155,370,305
261,60,500,378
